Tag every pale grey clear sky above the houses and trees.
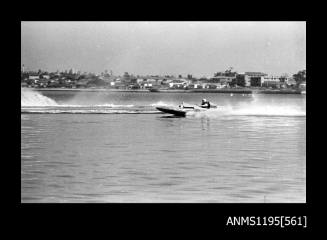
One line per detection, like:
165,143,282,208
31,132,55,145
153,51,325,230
21,21,306,77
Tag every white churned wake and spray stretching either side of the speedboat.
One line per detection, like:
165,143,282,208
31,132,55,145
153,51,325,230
21,89,306,118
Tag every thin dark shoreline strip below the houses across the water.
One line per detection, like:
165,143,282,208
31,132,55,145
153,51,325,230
26,88,302,94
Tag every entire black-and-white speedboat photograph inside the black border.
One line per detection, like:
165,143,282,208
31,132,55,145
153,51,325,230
20,21,307,204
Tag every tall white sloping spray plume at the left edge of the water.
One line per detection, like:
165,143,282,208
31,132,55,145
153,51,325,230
21,88,58,107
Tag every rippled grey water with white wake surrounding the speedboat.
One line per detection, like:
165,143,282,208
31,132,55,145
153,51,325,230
21,90,306,203
